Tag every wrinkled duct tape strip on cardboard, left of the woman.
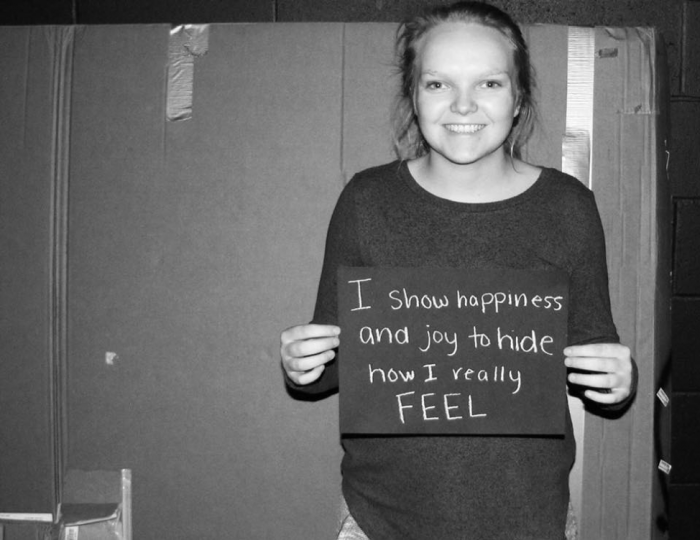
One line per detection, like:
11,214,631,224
166,24,209,122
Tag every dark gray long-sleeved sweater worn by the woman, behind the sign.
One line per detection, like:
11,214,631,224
290,162,632,540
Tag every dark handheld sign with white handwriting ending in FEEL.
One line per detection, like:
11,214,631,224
338,267,568,435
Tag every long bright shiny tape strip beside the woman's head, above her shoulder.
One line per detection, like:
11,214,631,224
562,26,595,189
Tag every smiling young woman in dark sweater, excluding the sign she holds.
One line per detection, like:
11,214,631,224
281,2,636,540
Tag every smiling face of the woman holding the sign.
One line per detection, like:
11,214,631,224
414,22,518,169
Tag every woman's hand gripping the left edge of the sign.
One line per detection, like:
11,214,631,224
280,324,340,385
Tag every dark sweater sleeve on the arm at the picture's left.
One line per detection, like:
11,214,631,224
285,181,363,396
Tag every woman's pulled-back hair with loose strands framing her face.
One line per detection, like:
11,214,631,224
392,1,537,159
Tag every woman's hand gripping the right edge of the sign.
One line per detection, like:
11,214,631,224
564,343,633,405
